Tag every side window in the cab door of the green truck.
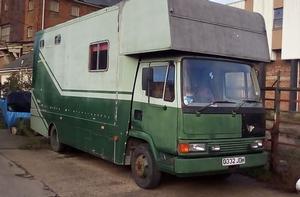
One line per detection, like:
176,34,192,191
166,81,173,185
142,65,175,102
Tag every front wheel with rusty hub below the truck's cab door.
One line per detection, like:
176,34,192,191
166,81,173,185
131,144,161,189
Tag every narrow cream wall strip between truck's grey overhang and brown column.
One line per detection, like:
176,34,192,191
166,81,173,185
253,0,276,60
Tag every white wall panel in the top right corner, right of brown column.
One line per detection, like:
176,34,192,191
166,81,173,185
282,0,300,60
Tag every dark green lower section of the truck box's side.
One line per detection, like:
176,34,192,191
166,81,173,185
32,49,130,164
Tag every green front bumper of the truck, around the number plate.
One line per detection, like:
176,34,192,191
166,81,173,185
174,152,268,175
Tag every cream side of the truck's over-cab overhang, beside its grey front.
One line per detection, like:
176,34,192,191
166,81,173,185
120,0,171,54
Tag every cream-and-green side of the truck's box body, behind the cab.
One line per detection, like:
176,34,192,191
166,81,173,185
31,9,137,164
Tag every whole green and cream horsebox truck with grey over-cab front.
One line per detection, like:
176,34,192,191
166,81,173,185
31,0,269,188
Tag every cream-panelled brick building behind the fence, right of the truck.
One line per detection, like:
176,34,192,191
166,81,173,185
229,0,300,111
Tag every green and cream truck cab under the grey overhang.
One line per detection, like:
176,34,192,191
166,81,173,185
129,56,267,187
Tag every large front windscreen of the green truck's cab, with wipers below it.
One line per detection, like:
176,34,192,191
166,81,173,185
182,58,260,106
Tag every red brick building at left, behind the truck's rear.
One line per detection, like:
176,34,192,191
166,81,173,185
0,0,120,91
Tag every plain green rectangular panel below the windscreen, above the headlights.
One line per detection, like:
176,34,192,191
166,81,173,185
181,114,242,139
